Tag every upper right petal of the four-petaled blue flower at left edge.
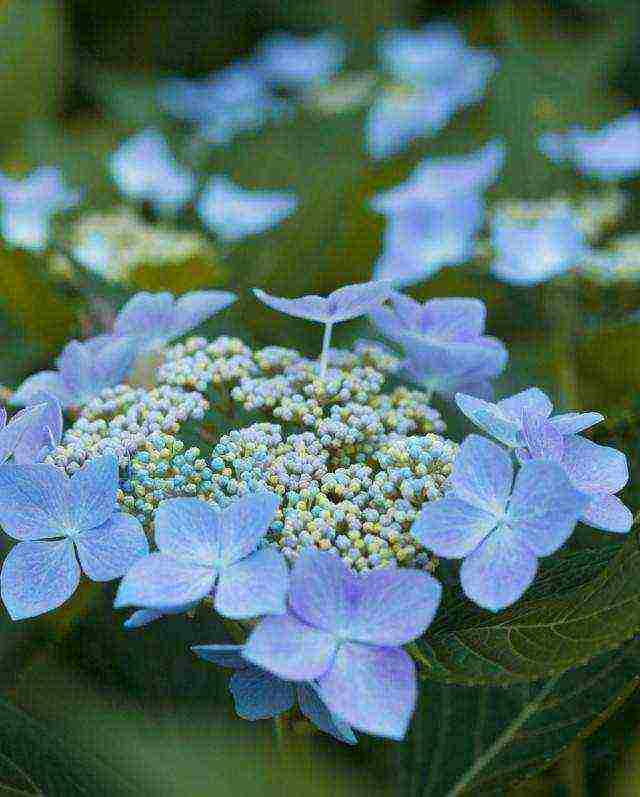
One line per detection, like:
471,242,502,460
69,454,119,532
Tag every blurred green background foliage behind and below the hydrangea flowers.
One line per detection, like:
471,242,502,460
0,0,640,797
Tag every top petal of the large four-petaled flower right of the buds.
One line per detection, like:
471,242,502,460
449,434,513,515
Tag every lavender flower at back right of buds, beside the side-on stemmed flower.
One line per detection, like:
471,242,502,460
370,291,508,396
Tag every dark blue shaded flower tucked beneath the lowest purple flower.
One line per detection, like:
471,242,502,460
191,645,358,744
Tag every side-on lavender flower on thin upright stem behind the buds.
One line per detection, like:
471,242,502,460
253,280,391,379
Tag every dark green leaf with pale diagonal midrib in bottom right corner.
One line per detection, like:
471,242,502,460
399,640,640,797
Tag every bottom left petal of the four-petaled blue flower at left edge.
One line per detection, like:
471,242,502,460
0,540,80,620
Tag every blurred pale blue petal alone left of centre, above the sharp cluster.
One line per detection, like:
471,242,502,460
196,175,298,241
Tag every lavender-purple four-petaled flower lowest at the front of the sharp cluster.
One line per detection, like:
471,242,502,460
242,549,441,739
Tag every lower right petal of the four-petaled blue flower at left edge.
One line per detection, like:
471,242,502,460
75,512,149,581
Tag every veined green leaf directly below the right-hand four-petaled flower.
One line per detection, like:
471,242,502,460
413,532,640,684
